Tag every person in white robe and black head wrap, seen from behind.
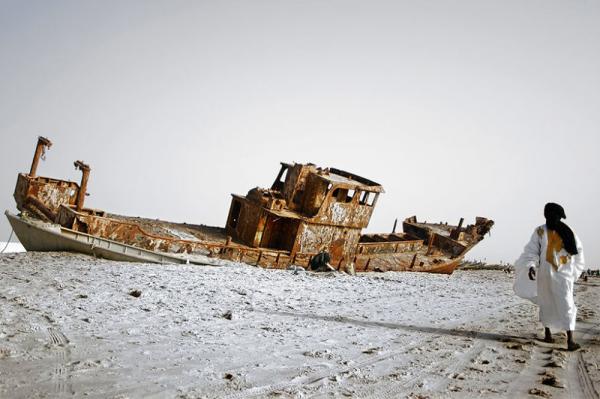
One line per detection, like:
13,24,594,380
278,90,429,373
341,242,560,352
514,202,585,351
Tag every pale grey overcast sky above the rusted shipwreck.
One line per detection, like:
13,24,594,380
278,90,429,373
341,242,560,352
0,0,600,264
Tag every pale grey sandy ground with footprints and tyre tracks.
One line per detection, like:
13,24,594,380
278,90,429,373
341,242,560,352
0,253,600,398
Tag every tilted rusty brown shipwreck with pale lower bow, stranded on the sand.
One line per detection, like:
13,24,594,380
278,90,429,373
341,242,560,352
6,137,494,273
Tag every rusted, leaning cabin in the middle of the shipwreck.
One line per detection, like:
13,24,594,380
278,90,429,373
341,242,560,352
226,163,384,263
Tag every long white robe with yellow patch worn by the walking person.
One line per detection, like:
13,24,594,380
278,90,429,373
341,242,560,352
513,225,585,331
